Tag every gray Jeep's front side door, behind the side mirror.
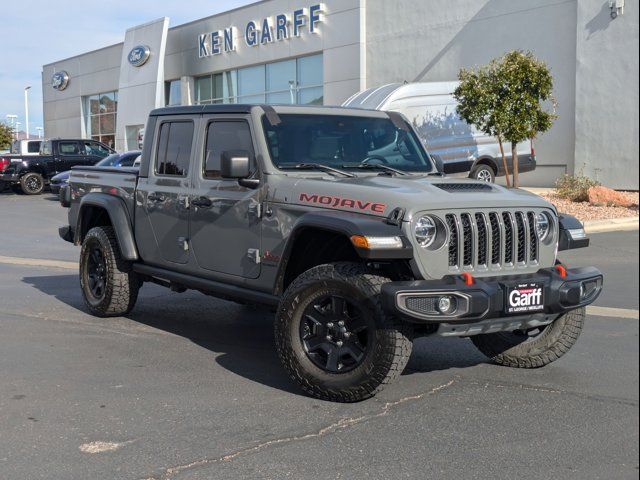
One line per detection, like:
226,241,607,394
190,116,260,278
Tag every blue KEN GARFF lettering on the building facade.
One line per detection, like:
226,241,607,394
198,3,324,58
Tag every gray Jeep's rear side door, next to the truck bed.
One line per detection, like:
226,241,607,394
135,118,195,268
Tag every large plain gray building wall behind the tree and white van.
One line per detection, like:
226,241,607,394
367,0,576,186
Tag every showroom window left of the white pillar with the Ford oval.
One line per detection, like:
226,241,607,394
84,92,118,148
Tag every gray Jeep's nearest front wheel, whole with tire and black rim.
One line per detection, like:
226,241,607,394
275,263,412,402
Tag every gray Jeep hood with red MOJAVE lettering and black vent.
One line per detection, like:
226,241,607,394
270,175,553,220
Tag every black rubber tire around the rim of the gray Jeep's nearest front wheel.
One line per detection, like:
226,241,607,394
275,263,412,402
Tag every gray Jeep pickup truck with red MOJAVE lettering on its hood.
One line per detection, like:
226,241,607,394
60,105,603,402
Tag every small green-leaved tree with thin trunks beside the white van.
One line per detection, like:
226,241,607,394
454,50,557,187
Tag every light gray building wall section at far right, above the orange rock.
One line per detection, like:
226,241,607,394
576,0,639,190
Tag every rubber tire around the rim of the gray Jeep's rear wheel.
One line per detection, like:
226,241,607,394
80,226,142,317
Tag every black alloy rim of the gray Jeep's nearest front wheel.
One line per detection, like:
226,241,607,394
300,295,375,373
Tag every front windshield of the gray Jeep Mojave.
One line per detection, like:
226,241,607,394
263,114,433,172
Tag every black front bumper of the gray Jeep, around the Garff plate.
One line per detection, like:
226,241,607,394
382,267,603,333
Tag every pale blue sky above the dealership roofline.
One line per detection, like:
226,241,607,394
0,0,255,134
